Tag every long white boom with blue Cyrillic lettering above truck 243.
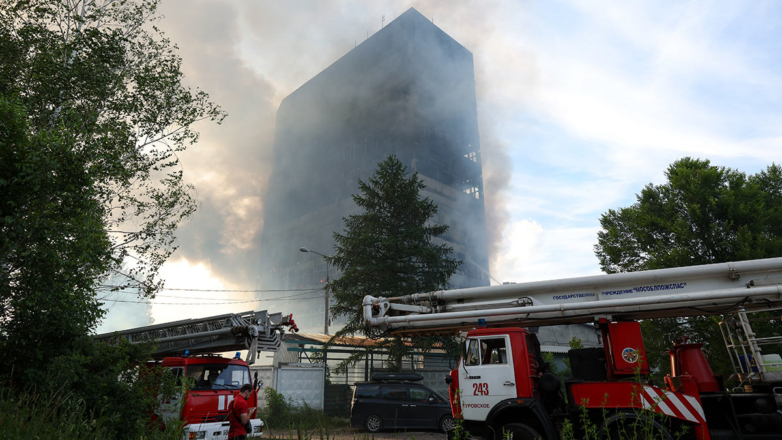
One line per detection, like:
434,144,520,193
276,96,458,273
363,258,782,335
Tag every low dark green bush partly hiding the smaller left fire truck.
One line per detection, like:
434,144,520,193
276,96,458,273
19,337,181,439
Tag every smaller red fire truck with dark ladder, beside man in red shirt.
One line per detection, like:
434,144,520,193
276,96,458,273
95,311,298,440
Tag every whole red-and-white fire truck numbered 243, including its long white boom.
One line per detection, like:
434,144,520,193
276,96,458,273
362,258,782,440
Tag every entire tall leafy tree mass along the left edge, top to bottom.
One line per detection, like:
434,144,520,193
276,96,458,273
0,0,224,436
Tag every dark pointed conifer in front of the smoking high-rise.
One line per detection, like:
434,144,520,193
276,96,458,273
328,155,461,367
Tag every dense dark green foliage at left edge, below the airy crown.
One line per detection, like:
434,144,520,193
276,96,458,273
0,96,111,382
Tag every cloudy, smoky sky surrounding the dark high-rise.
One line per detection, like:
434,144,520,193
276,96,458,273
98,0,782,332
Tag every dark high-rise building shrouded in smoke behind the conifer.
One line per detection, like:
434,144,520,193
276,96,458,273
260,9,489,330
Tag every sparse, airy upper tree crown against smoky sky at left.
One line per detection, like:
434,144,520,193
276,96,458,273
0,0,224,295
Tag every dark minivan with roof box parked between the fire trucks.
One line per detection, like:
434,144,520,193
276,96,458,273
350,373,454,432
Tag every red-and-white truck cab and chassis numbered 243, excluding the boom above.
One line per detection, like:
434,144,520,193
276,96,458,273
447,320,782,440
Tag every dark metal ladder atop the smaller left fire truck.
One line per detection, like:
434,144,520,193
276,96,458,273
95,310,298,364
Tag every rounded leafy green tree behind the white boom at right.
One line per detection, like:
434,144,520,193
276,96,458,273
595,158,782,374
